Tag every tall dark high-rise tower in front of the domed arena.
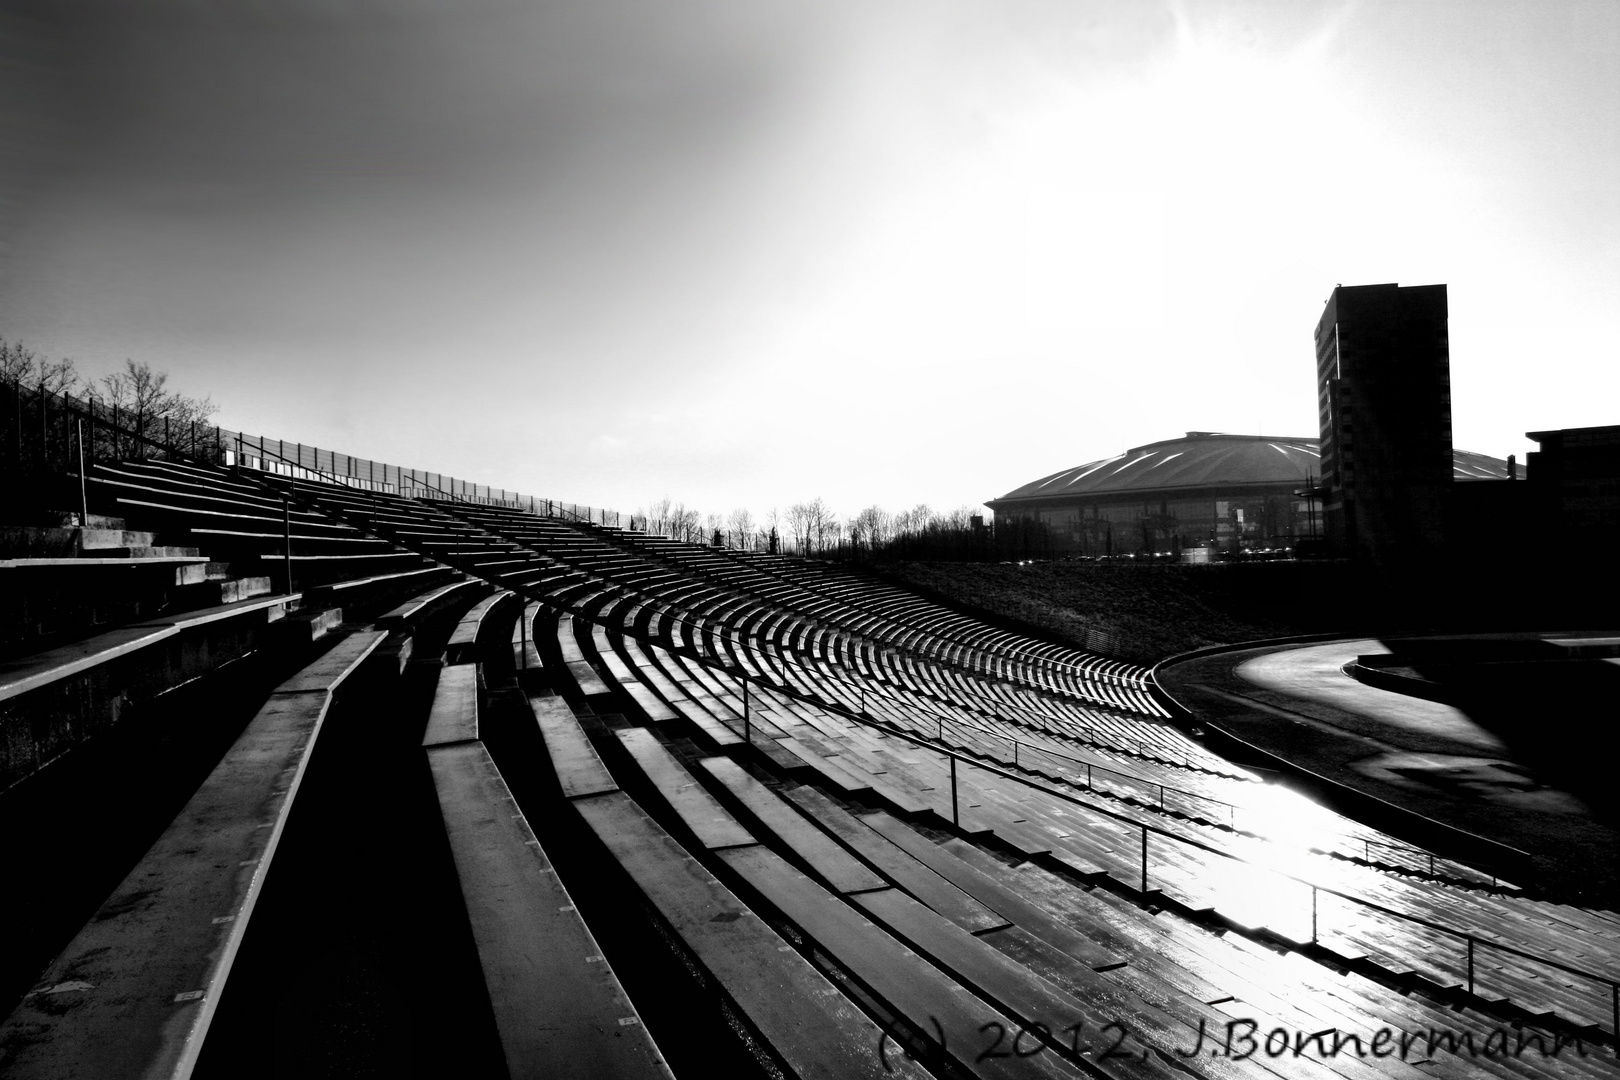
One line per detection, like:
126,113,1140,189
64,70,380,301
1315,285,1452,562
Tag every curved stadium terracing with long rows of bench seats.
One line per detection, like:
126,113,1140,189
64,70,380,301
0,383,1620,1078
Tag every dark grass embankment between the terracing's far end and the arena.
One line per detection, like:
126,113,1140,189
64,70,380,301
876,562,1382,664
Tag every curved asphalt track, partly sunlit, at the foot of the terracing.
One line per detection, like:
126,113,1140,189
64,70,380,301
1155,638,1620,908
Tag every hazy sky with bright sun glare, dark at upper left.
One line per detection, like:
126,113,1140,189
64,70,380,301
0,0,1620,515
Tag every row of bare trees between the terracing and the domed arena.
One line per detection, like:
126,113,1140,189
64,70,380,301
630,495,985,555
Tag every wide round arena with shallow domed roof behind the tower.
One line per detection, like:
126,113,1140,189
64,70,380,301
987,431,1508,559
